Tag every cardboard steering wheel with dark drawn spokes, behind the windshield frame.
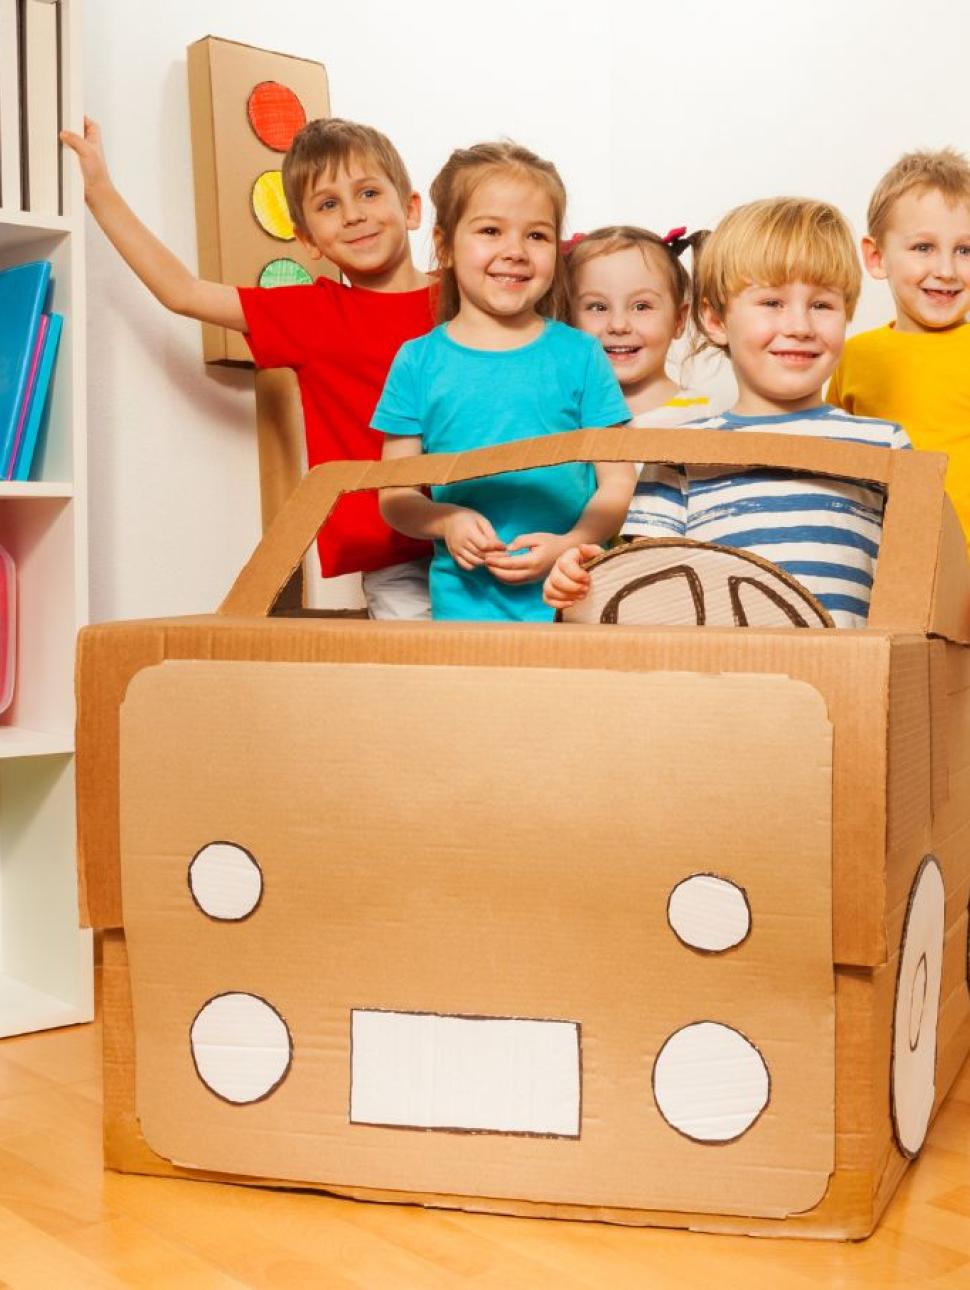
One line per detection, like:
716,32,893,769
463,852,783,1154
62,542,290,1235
556,538,835,627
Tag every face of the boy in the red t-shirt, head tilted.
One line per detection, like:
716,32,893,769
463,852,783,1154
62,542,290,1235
297,156,421,290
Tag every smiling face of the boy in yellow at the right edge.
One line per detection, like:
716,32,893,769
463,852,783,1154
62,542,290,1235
862,188,970,332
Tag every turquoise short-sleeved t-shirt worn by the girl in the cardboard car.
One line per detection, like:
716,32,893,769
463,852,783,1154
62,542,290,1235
371,321,629,622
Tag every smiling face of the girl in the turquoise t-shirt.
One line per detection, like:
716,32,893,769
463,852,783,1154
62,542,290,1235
439,174,559,332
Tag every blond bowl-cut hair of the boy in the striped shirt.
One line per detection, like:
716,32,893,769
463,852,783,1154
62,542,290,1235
693,197,862,348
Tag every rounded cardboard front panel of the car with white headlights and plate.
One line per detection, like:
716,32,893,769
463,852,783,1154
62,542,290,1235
121,660,835,1216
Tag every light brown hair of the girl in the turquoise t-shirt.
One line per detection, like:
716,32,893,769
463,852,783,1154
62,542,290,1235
431,141,568,323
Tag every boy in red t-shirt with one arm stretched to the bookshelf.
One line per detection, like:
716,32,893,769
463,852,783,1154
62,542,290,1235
61,117,435,618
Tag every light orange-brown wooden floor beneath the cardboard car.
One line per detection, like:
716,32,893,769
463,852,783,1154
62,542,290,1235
0,990,970,1290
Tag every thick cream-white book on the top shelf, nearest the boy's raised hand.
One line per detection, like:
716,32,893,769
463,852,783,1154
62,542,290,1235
21,0,61,215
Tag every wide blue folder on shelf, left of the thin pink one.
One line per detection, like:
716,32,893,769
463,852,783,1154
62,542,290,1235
0,259,50,466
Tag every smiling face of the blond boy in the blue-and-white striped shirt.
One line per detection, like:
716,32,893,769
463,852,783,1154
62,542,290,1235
700,281,846,415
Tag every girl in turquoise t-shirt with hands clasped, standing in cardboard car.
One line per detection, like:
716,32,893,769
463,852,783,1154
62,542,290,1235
373,143,633,622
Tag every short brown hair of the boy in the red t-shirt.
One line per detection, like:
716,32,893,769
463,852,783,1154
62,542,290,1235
282,116,414,233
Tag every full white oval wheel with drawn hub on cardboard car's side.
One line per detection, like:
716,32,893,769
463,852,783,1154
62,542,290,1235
891,855,944,1157
